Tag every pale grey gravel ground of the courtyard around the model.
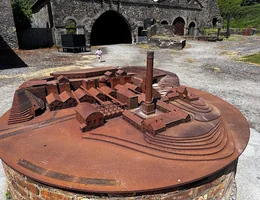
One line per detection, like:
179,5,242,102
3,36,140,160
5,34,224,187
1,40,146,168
0,36,260,200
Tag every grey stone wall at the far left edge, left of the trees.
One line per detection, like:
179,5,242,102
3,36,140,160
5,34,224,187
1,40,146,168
0,0,18,50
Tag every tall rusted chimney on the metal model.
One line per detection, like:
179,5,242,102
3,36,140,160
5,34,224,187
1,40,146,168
141,51,155,115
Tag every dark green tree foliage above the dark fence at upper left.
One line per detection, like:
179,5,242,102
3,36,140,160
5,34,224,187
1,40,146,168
11,0,34,31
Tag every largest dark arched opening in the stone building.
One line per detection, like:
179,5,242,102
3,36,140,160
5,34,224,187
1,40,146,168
90,10,132,46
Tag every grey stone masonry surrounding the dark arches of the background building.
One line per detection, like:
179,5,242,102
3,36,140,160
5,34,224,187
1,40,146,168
31,0,220,44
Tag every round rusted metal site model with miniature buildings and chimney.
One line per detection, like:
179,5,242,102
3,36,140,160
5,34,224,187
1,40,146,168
0,52,249,194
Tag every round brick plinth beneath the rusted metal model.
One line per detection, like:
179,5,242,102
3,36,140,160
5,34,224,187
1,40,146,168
3,161,237,200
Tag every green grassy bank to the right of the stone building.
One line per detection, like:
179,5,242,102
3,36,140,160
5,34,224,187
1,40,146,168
218,0,260,29
